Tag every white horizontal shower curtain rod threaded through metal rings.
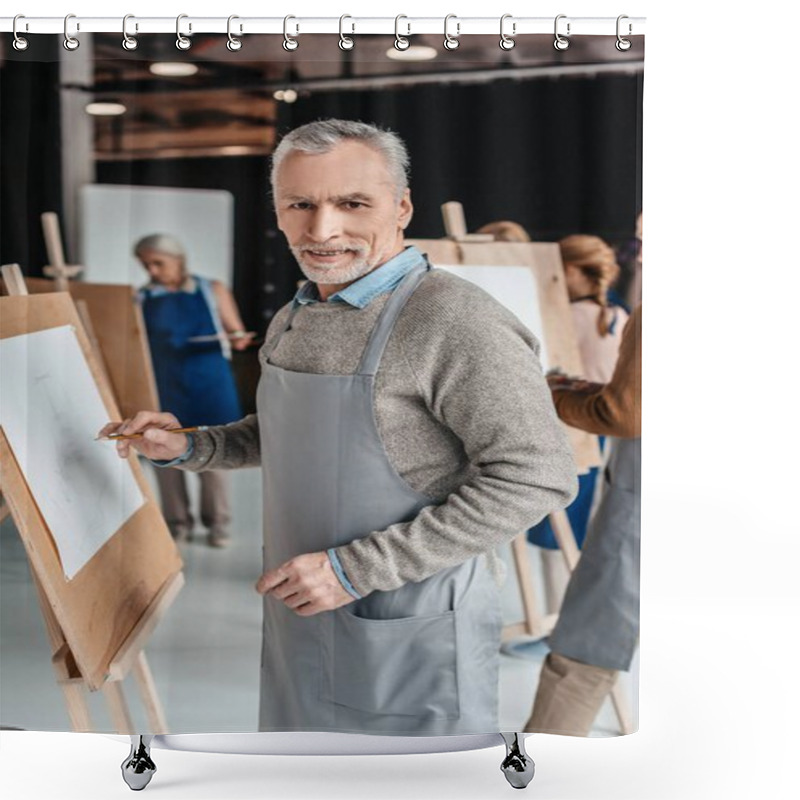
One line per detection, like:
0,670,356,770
0,14,645,37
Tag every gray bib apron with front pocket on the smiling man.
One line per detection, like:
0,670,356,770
257,264,502,736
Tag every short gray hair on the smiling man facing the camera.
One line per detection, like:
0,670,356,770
269,119,409,200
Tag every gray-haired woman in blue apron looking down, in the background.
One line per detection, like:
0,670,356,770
133,234,252,547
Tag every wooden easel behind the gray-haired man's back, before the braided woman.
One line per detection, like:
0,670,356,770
409,208,633,733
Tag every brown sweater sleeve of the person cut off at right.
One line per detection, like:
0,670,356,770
553,305,642,439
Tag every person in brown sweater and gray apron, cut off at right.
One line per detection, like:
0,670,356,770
524,305,642,736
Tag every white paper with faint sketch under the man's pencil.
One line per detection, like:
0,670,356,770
0,325,144,580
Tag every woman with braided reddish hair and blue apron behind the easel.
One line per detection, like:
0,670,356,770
528,233,628,613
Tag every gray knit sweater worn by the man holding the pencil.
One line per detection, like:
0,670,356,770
177,270,577,595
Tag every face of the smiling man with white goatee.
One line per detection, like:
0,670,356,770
275,140,413,286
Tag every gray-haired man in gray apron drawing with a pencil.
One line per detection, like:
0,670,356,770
104,120,577,735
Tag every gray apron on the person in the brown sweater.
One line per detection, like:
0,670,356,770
549,439,642,670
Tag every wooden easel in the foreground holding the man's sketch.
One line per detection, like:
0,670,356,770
0,264,184,734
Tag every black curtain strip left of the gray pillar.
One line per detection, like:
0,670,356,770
0,36,63,276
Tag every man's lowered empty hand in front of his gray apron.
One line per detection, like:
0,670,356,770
256,552,355,617
